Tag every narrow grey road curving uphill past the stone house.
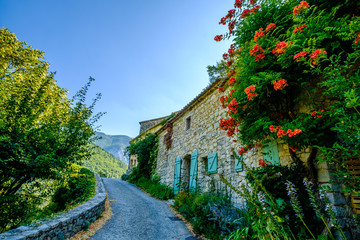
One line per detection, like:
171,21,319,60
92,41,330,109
90,178,197,240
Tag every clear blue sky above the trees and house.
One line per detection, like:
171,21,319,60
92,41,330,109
0,0,235,137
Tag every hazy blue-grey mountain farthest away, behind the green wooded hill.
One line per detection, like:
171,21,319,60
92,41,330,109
95,132,132,164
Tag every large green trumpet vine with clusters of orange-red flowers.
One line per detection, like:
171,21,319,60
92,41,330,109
217,0,360,191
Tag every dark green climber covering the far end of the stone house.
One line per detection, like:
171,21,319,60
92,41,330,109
127,133,158,183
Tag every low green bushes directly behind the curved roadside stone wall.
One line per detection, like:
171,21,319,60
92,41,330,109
0,165,96,232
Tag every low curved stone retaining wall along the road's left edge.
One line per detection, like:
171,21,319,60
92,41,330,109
0,173,106,240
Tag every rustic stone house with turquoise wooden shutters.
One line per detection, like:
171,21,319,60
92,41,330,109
130,79,355,229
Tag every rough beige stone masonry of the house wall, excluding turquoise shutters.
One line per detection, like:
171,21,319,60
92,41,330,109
156,81,309,205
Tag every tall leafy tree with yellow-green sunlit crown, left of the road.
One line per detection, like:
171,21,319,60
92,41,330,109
0,28,102,231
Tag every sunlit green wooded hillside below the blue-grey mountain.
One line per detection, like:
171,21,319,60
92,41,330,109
82,145,128,178
